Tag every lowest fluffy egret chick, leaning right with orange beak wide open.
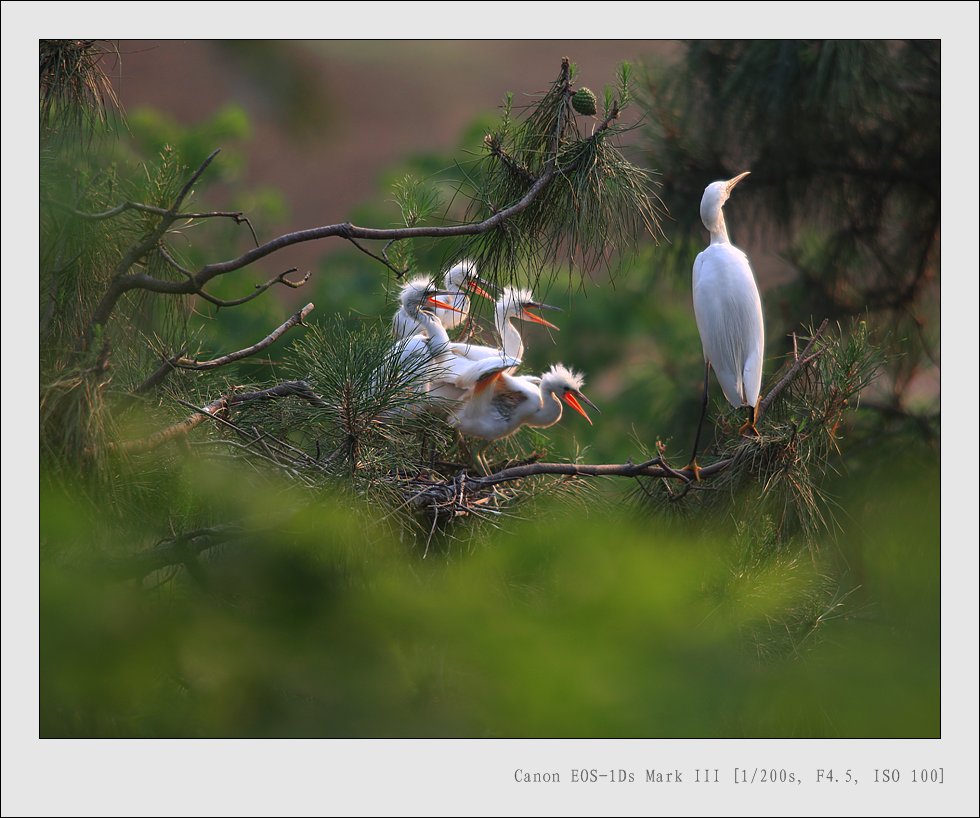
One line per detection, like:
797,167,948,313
449,364,599,441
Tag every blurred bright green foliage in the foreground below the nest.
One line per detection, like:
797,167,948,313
40,450,940,737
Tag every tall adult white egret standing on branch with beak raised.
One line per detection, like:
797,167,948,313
688,171,765,478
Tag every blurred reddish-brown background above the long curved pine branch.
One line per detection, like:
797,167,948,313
111,40,682,266
